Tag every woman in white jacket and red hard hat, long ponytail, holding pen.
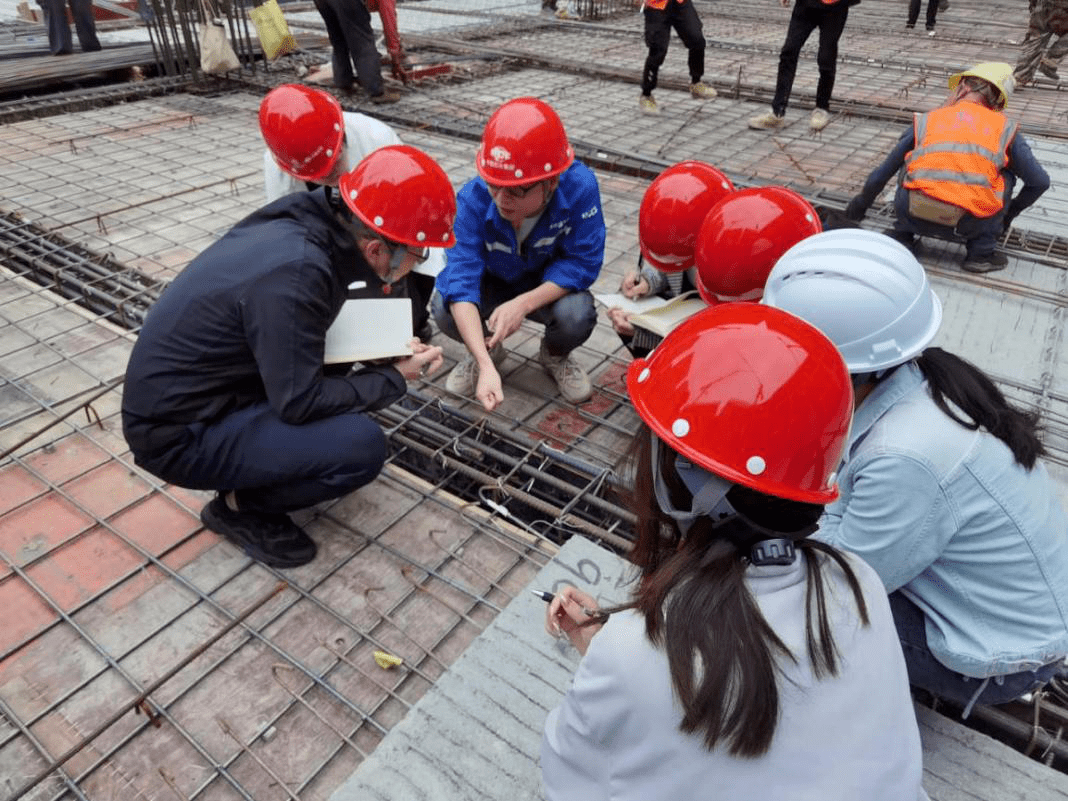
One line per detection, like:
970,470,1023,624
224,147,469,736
541,303,927,801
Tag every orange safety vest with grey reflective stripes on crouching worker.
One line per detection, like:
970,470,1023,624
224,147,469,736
904,101,1017,217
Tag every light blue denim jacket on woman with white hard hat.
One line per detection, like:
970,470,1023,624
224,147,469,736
816,362,1068,678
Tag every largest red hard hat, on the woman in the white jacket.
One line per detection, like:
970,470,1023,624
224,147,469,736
627,303,853,504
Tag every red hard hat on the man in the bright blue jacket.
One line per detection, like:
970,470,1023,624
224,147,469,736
474,97,575,186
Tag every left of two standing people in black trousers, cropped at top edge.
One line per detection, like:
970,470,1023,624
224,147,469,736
638,0,716,114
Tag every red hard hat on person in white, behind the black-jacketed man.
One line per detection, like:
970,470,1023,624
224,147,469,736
260,83,345,183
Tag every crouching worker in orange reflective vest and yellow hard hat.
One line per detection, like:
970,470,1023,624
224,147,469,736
846,62,1050,272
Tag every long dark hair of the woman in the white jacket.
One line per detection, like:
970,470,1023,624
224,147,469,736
630,427,868,757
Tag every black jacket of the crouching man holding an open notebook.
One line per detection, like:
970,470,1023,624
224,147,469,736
123,190,406,453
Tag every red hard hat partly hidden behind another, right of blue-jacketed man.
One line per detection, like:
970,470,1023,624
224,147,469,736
638,161,734,272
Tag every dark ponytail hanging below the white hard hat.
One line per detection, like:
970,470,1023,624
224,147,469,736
916,348,1046,470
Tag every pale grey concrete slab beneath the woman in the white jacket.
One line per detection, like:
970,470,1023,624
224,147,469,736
330,536,1068,801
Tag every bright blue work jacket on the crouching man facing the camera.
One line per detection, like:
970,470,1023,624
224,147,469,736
436,161,604,304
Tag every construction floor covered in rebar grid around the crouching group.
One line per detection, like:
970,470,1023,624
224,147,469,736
0,0,1068,801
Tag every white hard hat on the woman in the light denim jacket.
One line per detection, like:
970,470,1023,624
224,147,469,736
763,229,942,373
